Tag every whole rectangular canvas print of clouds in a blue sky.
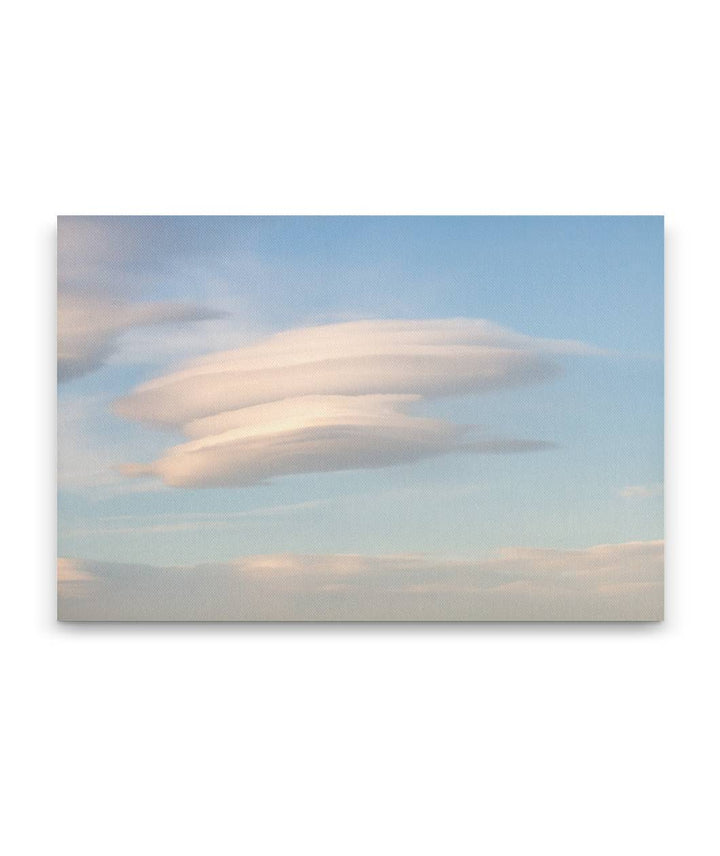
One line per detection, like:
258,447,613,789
57,216,663,621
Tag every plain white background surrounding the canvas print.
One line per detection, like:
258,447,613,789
0,0,720,856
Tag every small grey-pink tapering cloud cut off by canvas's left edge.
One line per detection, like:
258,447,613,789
58,291,220,381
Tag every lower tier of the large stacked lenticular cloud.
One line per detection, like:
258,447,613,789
123,395,549,487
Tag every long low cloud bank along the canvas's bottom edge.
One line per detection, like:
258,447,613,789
58,541,664,621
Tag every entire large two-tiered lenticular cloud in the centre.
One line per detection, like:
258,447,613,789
114,319,596,487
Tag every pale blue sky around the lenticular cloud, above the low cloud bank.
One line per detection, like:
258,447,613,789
58,217,663,580
